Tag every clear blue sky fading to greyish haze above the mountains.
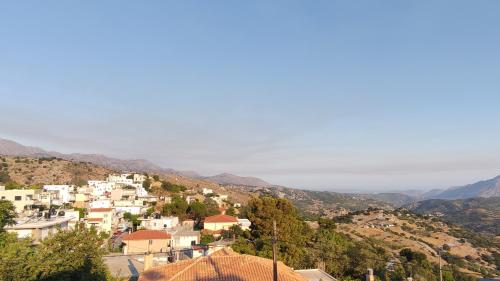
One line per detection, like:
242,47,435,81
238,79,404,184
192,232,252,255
0,0,500,191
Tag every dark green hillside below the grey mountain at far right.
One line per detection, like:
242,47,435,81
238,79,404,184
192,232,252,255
405,197,500,235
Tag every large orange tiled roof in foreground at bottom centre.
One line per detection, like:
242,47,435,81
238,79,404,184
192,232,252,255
139,248,306,281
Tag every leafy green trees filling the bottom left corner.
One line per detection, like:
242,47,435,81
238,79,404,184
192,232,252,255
0,225,111,281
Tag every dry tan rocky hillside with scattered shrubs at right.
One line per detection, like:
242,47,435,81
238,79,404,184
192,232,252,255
337,210,500,276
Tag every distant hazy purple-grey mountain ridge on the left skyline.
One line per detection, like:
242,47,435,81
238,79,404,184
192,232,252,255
0,138,271,186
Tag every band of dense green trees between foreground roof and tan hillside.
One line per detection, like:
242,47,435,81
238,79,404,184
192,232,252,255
229,196,475,281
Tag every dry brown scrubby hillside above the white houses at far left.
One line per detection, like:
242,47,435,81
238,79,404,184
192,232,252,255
0,157,112,185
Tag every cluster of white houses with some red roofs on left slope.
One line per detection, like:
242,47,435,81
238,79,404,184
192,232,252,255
0,160,256,277
